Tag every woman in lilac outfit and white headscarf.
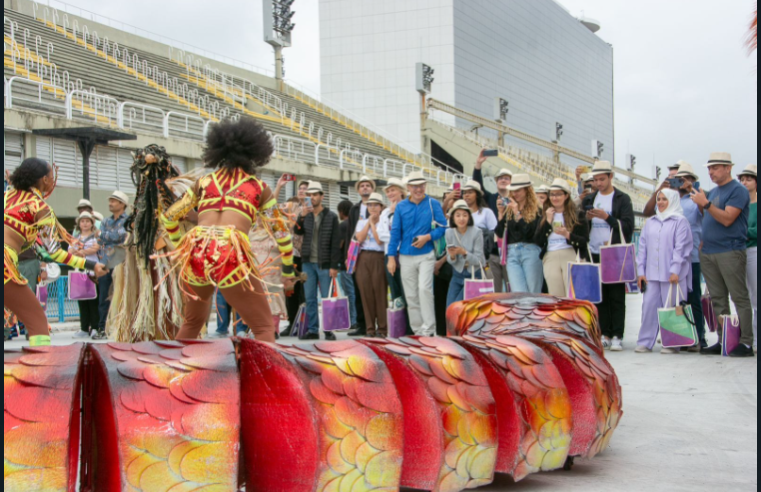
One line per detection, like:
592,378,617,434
635,190,693,354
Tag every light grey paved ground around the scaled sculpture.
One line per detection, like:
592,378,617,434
5,296,758,492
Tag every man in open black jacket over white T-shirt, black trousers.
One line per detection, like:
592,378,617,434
582,161,634,352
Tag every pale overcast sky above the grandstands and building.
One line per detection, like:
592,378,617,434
52,0,758,181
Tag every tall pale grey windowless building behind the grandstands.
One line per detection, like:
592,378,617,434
320,0,614,162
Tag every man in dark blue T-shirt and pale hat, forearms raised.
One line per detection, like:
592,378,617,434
692,152,755,357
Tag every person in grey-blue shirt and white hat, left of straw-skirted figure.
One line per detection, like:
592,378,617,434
94,191,129,338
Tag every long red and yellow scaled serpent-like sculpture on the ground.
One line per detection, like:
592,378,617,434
4,295,622,492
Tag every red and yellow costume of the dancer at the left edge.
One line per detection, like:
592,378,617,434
3,189,95,285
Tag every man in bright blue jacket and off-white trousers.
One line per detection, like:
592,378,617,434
388,172,447,337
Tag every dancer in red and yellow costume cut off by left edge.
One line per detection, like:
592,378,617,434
3,159,105,347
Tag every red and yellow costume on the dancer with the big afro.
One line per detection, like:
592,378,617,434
162,169,294,289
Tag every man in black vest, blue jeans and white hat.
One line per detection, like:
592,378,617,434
295,181,342,340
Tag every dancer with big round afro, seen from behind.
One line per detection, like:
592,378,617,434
161,117,294,342
